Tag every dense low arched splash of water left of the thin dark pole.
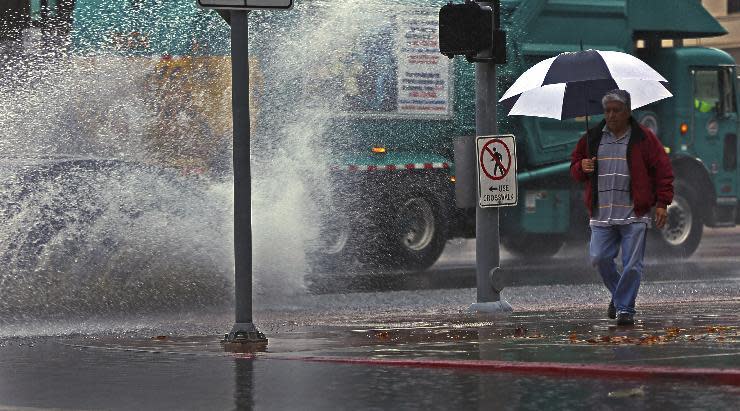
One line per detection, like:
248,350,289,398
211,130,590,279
0,160,233,320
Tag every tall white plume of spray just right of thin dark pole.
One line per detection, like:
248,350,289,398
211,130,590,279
251,2,402,292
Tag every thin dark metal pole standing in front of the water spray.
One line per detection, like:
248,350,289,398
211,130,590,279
226,10,267,344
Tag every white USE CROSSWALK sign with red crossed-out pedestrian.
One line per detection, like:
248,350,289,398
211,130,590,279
475,134,518,207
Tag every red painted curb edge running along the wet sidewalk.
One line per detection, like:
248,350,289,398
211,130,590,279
270,357,740,386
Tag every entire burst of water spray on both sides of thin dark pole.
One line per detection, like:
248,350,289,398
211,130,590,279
0,2,422,326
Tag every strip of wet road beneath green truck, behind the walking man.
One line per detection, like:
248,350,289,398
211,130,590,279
306,227,740,294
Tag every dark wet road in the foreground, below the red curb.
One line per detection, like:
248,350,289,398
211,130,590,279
0,342,740,411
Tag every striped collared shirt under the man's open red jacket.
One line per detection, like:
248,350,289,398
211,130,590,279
590,126,650,226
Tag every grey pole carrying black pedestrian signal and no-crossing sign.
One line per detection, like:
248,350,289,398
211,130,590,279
439,0,508,313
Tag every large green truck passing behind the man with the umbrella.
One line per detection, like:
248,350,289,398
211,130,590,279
304,0,738,268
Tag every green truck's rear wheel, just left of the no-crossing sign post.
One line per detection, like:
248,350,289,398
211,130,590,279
386,194,447,270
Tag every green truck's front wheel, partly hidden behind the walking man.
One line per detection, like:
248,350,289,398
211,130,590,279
653,181,704,258
